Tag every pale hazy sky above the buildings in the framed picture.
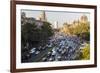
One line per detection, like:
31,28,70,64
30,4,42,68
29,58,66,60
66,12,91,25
21,10,90,26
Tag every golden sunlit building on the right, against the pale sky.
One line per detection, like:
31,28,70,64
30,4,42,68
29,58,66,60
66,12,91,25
61,15,90,35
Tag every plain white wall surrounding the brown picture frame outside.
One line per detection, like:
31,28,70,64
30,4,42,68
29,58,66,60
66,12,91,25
0,0,100,73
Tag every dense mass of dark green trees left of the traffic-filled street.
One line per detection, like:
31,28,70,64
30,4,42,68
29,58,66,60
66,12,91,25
21,22,53,60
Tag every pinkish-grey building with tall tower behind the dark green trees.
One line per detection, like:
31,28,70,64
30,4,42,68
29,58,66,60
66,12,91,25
21,11,46,28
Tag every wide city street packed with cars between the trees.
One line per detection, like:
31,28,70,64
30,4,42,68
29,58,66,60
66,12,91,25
28,33,86,62
